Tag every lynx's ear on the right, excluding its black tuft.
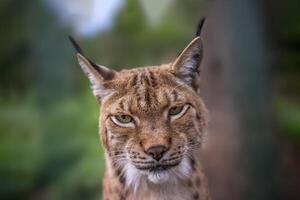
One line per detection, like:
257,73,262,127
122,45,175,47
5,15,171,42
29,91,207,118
172,37,203,92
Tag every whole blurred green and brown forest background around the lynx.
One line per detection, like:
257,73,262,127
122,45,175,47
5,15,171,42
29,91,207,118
0,0,300,200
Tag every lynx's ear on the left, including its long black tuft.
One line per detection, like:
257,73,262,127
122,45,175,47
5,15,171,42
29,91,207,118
69,37,116,100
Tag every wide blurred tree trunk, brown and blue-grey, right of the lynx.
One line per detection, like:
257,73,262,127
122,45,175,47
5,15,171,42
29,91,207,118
201,0,278,200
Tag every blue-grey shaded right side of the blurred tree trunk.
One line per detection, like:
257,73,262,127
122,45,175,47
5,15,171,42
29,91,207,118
224,0,281,200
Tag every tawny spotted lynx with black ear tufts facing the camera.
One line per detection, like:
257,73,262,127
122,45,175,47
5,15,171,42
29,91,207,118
70,21,210,200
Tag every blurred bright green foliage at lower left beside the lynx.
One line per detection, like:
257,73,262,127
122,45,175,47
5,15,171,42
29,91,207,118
0,94,104,199
